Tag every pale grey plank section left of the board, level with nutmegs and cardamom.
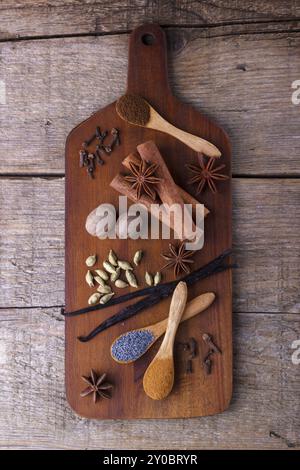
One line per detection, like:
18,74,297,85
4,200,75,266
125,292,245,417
0,178,64,306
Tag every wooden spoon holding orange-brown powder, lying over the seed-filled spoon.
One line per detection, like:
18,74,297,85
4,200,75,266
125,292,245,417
143,281,187,400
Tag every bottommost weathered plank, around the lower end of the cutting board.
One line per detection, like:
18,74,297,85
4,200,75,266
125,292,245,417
0,309,300,449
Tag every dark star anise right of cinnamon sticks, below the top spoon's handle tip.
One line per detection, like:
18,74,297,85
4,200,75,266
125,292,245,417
186,155,229,194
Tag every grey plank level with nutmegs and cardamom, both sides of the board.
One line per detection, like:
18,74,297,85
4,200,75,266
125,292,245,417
0,175,300,313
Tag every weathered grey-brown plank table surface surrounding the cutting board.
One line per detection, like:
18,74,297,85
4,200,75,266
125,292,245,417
0,0,300,449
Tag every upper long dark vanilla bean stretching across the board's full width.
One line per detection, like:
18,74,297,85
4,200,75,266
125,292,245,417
61,250,235,317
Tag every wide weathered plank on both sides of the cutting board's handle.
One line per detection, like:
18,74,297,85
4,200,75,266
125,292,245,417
0,29,300,175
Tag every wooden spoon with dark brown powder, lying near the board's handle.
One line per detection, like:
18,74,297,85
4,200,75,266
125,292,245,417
116,94,221,157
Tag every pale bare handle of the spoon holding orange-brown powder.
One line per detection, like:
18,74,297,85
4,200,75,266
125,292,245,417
160,281,187,352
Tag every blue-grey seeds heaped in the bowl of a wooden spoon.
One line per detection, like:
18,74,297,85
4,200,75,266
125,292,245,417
111,330,154,362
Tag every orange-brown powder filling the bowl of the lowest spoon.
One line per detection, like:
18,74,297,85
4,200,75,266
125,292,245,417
143,357,174,400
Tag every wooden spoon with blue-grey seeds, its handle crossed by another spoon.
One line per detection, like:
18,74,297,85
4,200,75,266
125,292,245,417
110,292,216,364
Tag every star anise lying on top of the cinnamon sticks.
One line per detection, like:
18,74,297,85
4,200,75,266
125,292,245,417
125,159,161,201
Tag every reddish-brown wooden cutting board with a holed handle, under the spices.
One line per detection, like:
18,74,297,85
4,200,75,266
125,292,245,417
65,25,232,419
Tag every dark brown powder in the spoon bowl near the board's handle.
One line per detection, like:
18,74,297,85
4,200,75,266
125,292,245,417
116,95,150,126
